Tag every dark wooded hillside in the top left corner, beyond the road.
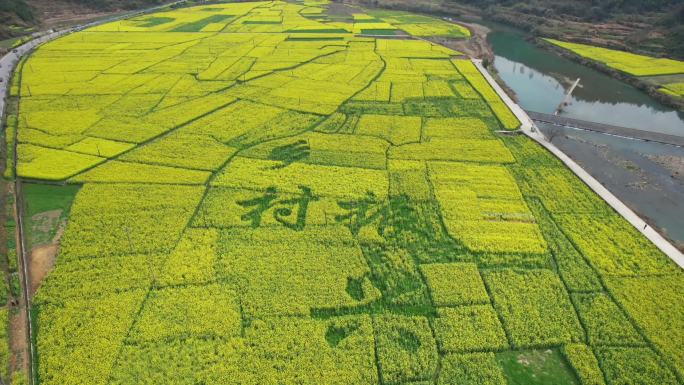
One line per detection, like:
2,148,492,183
0,0,166,40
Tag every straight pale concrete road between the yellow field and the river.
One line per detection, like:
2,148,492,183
473,59,684,269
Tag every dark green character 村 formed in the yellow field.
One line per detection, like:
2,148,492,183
237,186,318,231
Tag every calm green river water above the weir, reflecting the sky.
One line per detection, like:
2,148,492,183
489,27,684,136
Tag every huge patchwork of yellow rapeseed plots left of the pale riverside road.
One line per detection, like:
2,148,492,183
8,0,684,385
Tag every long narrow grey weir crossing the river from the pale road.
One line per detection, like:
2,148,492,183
525,111,684,147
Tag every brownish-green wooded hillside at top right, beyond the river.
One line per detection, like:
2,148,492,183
352,0,684,59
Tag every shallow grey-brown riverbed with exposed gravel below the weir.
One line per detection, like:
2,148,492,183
537,123,684,252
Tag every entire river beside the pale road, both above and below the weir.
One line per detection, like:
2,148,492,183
487,24,684,247
